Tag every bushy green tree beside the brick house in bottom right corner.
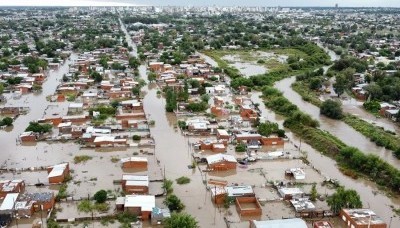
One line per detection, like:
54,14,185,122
327,187,362,214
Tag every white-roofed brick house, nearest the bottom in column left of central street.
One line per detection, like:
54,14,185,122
124,195,156,220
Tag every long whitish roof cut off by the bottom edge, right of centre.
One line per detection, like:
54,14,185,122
250,218,307,228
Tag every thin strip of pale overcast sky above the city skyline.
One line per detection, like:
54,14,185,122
0,0,400,7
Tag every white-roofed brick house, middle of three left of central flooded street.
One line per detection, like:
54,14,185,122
121,174,149,195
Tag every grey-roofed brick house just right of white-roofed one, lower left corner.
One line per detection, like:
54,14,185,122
19,192,55,212
